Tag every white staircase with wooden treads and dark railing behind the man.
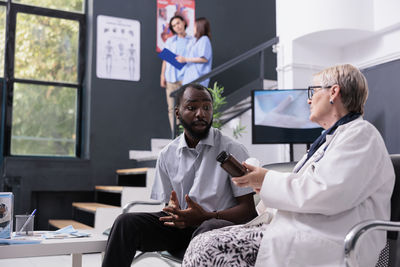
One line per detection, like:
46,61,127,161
49,37,279,232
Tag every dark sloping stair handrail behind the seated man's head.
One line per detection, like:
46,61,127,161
170,36,279,138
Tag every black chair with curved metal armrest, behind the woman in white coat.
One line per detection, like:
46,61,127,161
344,154,400,267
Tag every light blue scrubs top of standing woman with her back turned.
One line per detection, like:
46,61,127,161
182,35,212,87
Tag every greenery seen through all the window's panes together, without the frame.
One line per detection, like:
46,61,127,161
0,0,84,157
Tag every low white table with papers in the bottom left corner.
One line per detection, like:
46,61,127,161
0,231,107,267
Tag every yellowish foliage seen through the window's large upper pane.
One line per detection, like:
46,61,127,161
15,13,79,83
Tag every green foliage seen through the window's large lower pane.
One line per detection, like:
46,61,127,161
11,83,77,156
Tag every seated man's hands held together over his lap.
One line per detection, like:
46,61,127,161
160,195,211,229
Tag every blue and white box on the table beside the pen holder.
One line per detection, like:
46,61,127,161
0,192,14,238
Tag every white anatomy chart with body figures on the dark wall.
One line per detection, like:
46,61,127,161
96,15,140,81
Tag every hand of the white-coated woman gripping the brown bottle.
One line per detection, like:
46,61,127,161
232,162,268,193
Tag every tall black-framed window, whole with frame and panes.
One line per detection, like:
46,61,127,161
0,0,85,157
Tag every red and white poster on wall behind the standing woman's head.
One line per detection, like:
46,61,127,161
156,0,195,52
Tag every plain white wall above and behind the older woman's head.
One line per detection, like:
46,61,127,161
276,0,400,160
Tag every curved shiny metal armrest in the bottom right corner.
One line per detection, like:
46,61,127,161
344,220,400,267
